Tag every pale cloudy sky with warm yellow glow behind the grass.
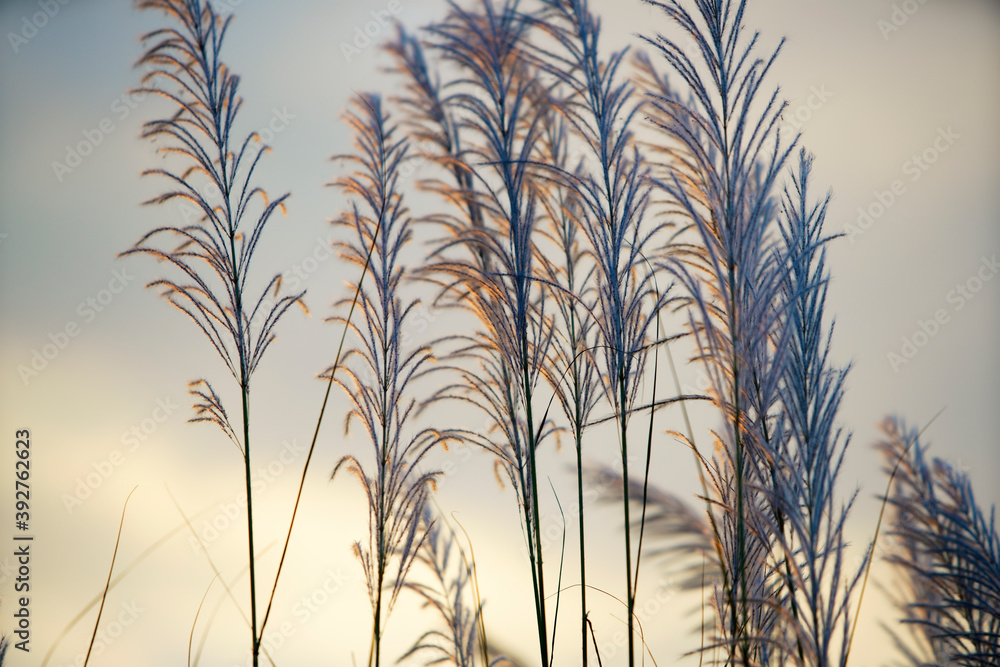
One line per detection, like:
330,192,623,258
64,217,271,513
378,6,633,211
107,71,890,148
0,0,1000,667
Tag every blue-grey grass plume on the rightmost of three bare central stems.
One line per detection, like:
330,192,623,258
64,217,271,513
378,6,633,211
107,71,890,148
539,0,665,665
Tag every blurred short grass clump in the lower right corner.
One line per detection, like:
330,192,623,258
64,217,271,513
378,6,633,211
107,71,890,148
878,418,1000,666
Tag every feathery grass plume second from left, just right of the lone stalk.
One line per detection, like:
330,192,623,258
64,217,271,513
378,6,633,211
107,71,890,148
330,95,447,667
